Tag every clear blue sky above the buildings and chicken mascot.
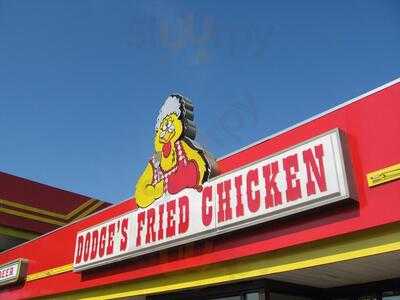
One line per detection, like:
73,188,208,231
0,0,400,202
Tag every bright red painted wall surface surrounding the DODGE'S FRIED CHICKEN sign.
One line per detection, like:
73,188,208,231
0,83,400,299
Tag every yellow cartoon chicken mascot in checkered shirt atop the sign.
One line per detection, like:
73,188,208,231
135,94,215,208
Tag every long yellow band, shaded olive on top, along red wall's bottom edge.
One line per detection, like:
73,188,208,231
34,223,400,300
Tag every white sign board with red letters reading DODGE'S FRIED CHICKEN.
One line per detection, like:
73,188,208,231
73,129,355,271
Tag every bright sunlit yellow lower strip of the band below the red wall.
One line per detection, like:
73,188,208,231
79,242,400,300
